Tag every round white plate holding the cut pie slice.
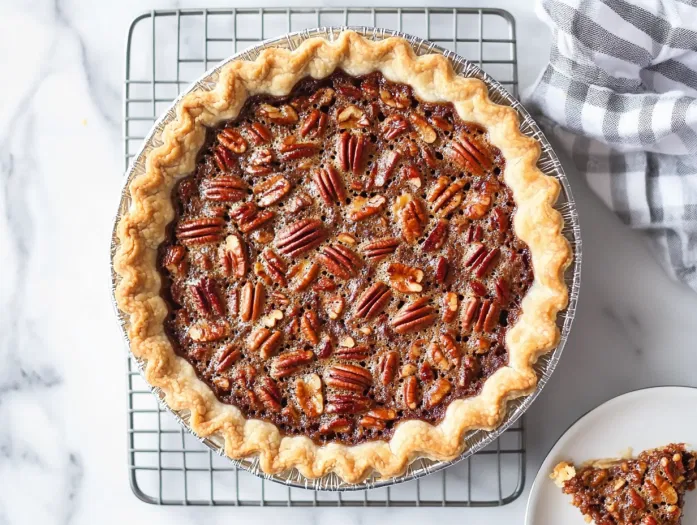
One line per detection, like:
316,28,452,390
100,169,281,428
525,386,697,525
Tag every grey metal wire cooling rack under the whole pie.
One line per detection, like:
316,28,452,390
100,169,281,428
123,8,525,507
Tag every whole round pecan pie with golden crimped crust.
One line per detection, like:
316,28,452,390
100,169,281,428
115,31,571,483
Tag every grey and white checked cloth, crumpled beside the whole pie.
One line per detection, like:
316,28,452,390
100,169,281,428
525,0,697,290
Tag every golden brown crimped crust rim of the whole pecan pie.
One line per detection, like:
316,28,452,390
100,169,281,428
114,31,571,483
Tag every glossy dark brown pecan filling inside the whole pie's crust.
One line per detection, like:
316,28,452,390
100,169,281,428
159,72,533,444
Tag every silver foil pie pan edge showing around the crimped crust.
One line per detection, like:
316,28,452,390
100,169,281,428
110,27,581,491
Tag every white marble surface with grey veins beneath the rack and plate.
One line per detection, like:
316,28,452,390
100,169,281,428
0,0,697,525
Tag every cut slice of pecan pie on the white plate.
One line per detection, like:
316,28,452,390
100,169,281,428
551,444,697,525
